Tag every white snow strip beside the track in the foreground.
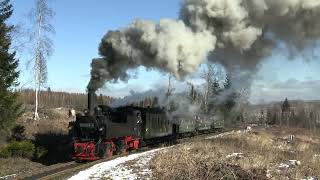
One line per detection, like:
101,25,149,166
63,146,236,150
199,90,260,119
69,148,166,180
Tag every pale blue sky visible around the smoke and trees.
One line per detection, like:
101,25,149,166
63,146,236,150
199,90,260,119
10,0,320,103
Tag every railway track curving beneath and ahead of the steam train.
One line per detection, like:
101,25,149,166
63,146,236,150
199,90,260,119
14,128,232,180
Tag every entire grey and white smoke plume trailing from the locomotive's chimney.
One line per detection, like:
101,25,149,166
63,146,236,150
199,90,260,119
88,0,320,90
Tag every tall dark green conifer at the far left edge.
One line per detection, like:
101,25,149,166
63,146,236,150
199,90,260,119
0,0,20,131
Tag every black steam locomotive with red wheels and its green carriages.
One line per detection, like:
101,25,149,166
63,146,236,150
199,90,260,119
70,92,223,161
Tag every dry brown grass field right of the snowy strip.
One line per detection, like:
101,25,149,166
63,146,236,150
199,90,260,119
151,128,320,179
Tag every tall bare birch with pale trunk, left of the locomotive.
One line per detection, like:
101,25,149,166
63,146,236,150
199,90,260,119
30,0,54,120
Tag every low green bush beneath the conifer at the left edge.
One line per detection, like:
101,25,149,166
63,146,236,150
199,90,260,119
0,140,35,159
